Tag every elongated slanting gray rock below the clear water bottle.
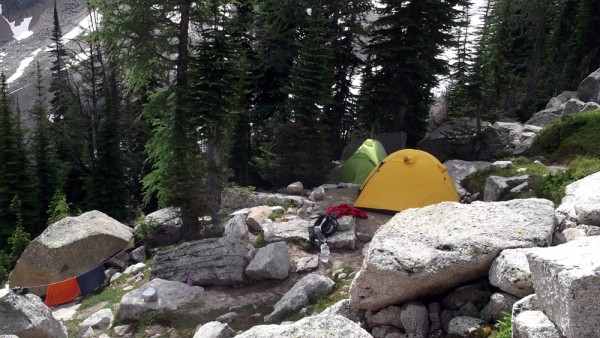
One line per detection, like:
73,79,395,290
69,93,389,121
265,274,334,324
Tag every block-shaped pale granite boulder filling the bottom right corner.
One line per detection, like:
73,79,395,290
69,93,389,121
527,236,600,337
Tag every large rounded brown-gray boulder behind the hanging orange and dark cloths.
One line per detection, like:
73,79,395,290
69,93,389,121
9,211,133,295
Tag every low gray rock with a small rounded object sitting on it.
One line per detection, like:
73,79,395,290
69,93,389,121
119,278,204,321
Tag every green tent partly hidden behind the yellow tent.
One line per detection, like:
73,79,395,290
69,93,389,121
341,139,387,184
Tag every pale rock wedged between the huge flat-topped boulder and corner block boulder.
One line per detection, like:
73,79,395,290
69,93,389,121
489,248,543,297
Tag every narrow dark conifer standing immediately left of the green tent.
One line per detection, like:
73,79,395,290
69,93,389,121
262,0,333,187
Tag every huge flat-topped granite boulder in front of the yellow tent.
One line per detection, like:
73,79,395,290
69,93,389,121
350,199,556,310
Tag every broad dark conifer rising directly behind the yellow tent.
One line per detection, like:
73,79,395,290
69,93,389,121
359,0,462,145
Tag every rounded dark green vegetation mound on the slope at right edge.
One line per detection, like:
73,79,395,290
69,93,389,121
528,110,600,161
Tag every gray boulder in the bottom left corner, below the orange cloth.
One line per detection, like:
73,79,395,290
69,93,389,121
0,292,67,338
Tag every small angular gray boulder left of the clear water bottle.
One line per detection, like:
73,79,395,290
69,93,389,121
246,242,290,279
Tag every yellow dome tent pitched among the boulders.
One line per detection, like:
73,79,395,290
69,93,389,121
354,149,459,211
